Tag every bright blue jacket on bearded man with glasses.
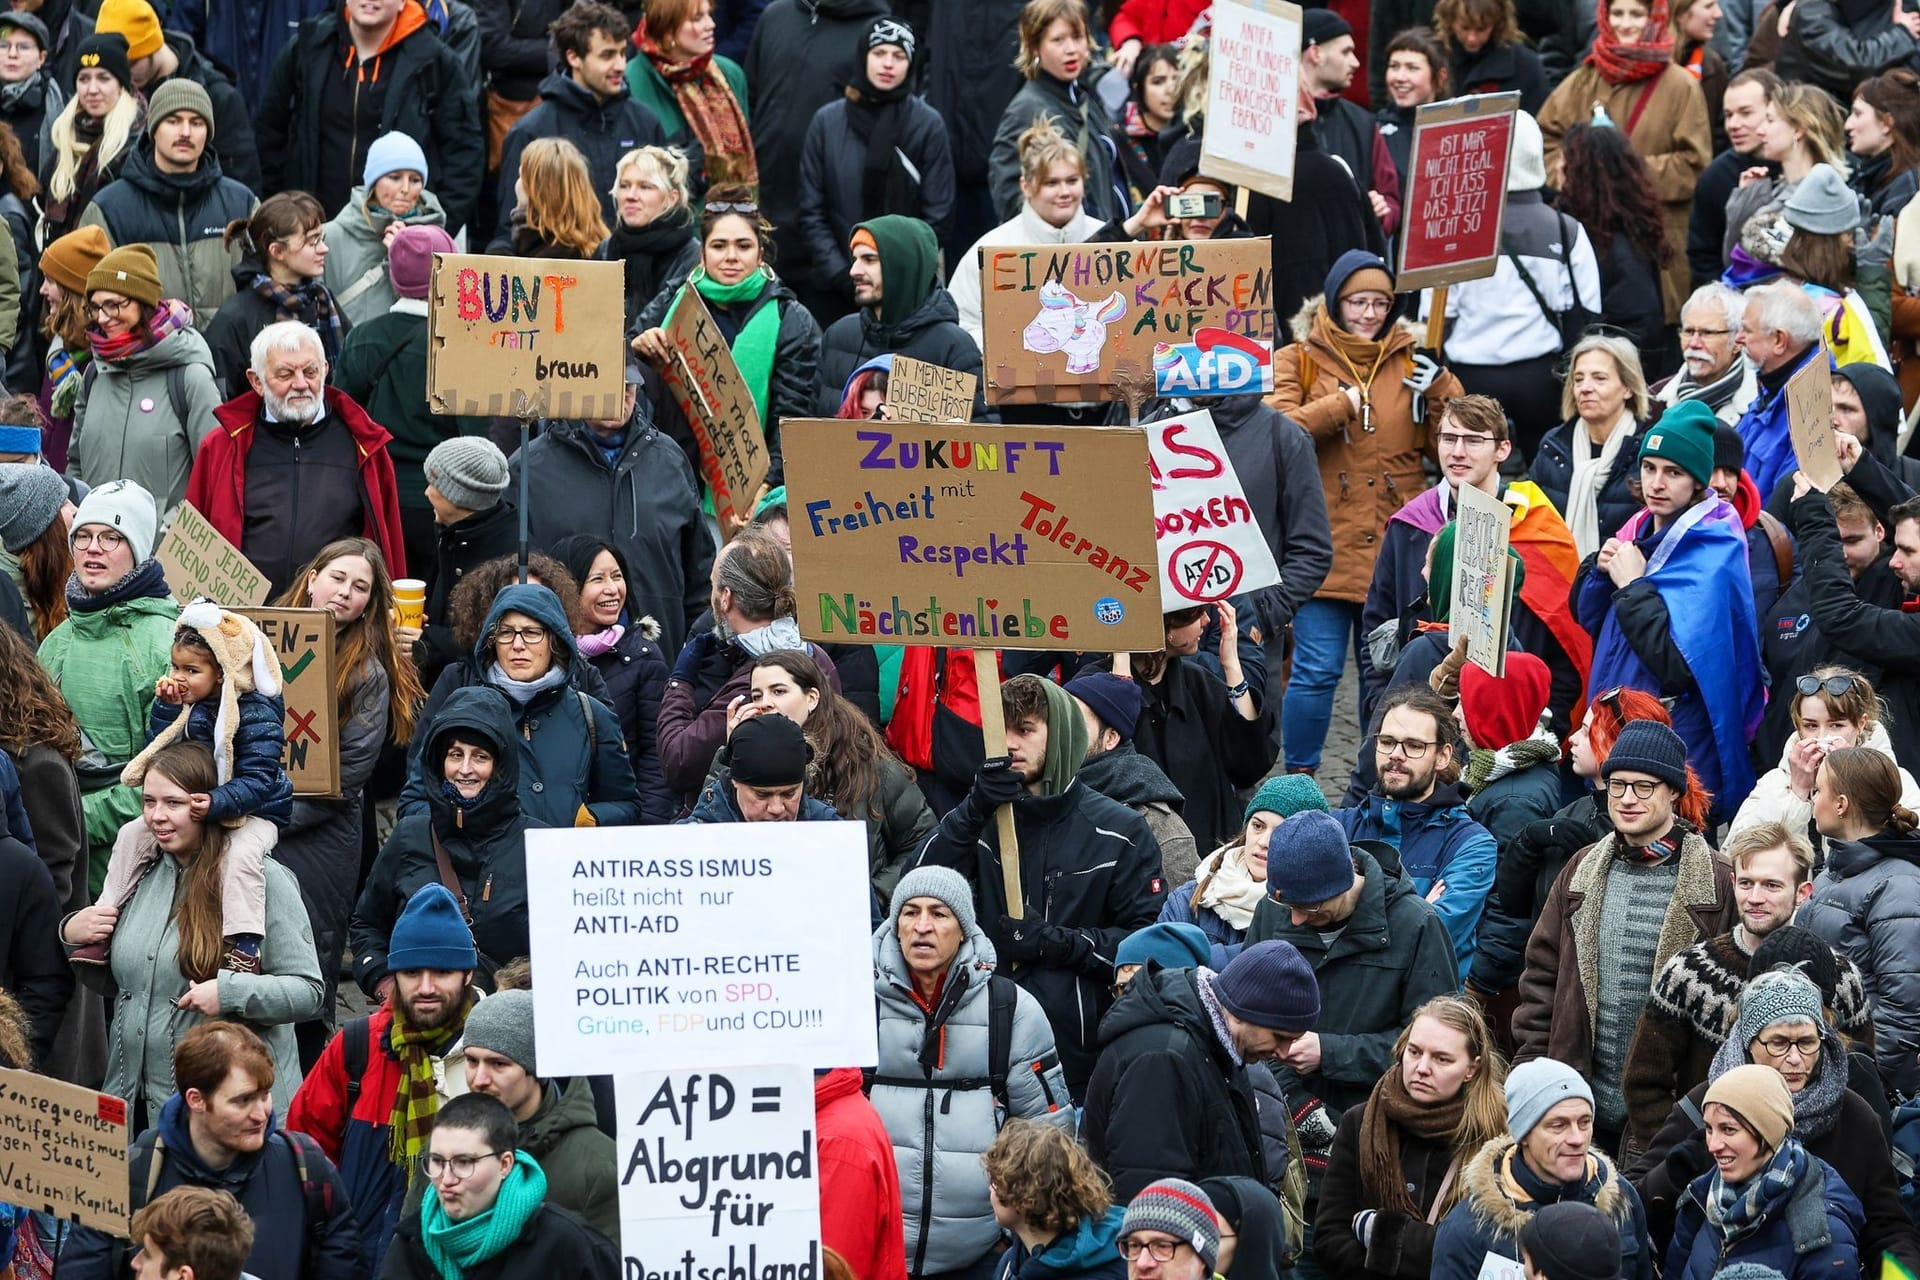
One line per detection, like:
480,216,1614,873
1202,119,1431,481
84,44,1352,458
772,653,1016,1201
1332,787,1500,981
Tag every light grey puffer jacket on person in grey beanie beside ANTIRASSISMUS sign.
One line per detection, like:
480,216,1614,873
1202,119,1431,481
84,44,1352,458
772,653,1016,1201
870,919,1073,1276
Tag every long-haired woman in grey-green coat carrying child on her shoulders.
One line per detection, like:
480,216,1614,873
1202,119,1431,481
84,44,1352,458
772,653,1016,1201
61,743,322,1128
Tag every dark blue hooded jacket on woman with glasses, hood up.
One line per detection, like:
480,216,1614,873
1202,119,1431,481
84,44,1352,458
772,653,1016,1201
399,583,645,832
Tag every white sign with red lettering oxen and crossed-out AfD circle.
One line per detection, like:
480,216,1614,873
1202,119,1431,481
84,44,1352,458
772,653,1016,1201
1146,411,1281,608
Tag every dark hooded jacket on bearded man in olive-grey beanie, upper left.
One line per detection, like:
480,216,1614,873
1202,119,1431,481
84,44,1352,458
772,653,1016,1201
79,146,259,332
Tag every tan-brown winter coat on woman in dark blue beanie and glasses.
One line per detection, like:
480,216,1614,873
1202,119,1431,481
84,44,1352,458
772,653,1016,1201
1267,297,1461,604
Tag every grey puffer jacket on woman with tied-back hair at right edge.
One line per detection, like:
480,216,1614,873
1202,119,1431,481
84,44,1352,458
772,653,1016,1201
1795,833,1920,1094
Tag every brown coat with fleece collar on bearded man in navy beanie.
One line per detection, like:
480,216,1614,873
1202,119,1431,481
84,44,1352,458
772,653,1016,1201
1513,831,1734,1075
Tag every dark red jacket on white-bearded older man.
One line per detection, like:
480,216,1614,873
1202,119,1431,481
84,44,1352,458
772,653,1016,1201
186,388,407,578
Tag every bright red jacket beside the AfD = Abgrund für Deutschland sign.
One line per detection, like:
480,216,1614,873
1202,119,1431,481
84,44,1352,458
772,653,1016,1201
814,1067,906,1280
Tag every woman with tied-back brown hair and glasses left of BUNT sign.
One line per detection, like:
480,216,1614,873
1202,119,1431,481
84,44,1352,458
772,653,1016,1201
207,192,353,397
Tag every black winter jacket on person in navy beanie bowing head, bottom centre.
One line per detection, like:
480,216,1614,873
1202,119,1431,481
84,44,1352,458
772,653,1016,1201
1081,961,1267,1199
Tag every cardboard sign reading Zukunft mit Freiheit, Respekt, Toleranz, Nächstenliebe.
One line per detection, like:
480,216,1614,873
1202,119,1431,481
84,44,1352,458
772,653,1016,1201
785,420,1165,652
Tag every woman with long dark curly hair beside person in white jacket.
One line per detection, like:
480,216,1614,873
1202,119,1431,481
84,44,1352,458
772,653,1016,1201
1553,123,1674,378
